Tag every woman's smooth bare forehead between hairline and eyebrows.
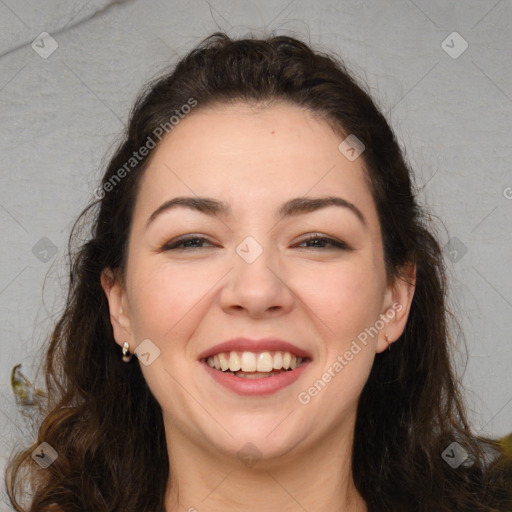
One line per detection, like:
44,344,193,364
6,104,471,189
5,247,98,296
135,103,376,228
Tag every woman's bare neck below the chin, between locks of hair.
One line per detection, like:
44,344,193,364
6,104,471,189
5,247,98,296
165,416,367,512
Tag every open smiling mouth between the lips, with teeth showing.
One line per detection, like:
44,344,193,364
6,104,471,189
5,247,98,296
201,350,311,379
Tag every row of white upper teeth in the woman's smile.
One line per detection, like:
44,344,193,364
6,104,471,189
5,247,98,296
206,352,302,370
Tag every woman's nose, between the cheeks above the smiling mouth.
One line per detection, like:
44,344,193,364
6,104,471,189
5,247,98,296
220,239,296,318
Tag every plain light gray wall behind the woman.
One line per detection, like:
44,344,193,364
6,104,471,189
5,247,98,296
0,0,512,509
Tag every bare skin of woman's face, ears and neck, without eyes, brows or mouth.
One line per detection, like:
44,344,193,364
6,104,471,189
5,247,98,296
102,103,415,512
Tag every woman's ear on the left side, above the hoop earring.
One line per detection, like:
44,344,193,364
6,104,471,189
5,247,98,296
101,268,134,347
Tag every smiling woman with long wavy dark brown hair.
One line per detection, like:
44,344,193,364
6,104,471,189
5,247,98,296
8,33,511,512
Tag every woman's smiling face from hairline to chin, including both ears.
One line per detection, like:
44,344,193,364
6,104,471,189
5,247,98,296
102,103,412,464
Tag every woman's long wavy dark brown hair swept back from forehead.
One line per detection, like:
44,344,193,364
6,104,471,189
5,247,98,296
6,33,512,512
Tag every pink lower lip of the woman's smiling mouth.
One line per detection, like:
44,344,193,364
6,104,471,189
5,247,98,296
202,361,311,396
